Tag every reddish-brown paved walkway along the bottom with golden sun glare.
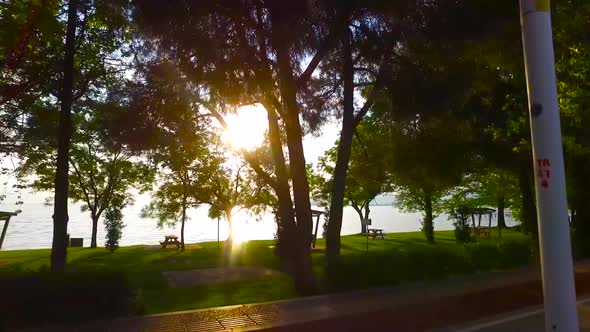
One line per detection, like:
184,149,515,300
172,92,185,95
17,262,590,332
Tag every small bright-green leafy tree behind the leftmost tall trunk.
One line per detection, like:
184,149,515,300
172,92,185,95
21,110,154,248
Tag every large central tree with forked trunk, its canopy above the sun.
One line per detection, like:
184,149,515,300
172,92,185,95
134,1,342,294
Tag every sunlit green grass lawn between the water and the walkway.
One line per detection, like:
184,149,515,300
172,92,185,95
0,230,530,313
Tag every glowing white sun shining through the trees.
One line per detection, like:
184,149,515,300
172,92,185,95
221,105,268,150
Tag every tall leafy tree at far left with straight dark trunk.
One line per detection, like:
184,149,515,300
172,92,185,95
0,0,132,271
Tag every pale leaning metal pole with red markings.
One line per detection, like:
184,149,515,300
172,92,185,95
520,0,579,331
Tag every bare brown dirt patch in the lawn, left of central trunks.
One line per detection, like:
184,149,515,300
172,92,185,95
162,266,282,288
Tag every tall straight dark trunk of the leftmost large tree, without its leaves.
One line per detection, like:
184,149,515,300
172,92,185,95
51,0,78,272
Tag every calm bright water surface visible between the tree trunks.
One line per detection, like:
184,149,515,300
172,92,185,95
0,199,514,250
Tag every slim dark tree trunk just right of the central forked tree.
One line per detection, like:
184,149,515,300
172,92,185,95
326,30,354,260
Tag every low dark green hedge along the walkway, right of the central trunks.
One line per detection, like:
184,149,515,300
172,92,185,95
322,240,531,292
